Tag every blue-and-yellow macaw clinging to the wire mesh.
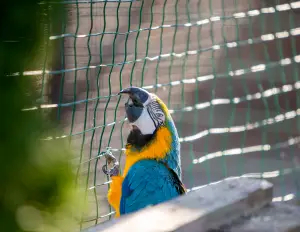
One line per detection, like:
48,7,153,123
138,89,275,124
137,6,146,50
108,87,186,217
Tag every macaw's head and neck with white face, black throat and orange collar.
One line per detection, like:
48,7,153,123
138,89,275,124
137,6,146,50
120,86,180,179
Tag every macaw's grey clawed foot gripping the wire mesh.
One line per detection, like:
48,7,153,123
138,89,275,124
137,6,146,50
101,147,120,177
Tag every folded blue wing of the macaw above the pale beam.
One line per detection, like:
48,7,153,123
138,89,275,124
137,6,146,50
120,160,180,214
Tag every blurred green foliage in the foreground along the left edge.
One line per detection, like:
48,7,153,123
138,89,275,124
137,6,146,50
0,0,82,232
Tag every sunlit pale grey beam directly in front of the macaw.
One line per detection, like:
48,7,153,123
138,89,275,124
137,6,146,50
85,178,273,232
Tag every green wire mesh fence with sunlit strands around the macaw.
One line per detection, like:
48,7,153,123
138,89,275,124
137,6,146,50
31,0,300,226
